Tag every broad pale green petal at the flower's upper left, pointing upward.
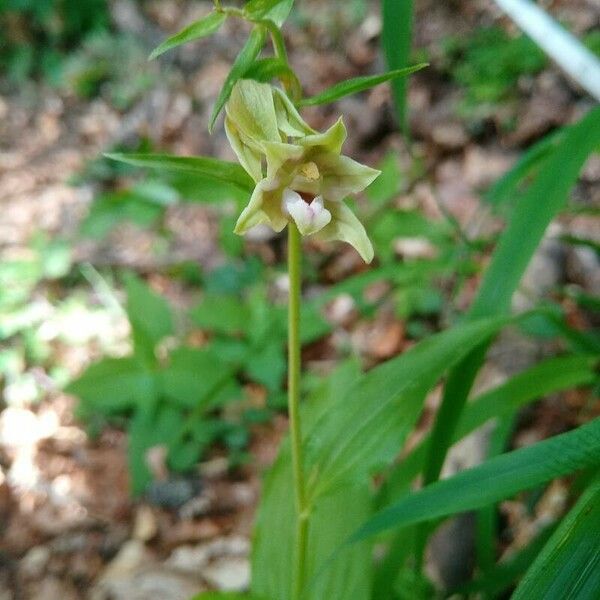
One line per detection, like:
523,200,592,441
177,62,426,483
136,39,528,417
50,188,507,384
225,79,281,145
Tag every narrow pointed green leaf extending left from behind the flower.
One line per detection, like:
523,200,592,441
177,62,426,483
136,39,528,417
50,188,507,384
105,154,254,193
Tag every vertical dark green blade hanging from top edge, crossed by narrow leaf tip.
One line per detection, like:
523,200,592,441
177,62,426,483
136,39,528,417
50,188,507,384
381,0,413,135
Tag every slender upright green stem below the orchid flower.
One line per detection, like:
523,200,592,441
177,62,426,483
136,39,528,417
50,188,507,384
288,220,308,600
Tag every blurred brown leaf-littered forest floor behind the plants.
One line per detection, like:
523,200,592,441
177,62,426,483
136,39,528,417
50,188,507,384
0,0,600,600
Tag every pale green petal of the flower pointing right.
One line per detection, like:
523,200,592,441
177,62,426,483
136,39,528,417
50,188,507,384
313,153,381,201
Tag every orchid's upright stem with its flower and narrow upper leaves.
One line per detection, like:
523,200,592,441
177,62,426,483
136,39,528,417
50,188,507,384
110,0,425,599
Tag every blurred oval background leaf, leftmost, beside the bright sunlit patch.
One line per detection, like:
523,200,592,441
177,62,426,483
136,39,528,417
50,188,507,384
65,358,156,415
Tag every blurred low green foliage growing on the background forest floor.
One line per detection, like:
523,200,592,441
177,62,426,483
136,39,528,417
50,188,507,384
0,0,600,492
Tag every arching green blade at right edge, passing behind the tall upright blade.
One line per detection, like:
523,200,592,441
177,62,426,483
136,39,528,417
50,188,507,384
379,355,598,503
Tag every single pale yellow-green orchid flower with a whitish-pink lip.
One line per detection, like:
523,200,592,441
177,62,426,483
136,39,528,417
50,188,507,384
225,79,379,262
